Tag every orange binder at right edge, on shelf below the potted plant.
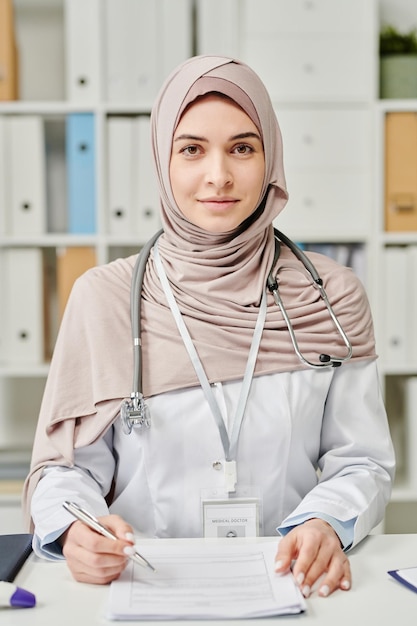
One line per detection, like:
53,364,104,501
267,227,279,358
385,111,417,231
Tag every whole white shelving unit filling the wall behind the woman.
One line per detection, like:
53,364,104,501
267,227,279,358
0,0,417,531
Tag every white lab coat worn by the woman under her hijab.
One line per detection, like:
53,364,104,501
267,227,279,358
32,360,394,555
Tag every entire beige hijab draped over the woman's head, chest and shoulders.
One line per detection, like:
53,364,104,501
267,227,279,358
24,56,375,519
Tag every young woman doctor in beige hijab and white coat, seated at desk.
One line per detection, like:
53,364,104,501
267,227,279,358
25,57,394,596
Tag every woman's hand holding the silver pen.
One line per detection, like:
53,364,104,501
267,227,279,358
60,515,134,585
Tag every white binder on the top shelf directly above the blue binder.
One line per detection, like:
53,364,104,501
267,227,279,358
64,0,102,103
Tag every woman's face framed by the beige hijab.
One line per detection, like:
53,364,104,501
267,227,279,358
170,95,265,233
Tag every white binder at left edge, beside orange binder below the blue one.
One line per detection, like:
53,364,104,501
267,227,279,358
1,248,44,364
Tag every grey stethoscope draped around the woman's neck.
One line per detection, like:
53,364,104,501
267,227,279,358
120,228,352,435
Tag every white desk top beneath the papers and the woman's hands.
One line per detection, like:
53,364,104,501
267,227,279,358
4,534,417,626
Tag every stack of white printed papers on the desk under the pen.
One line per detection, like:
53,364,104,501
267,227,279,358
108,539,306,620
